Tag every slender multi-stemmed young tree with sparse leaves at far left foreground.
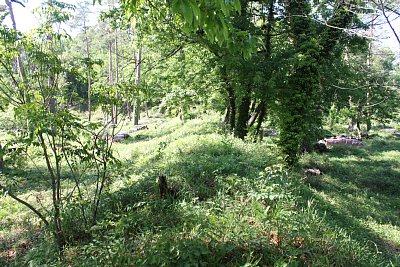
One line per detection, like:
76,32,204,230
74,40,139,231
0,1,116,251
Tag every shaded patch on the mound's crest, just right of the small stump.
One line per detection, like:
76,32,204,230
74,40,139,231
165,142,265,200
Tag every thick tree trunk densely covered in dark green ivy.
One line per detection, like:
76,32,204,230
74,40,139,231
278,0,321,167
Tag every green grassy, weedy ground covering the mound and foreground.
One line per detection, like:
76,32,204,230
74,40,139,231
0,112,400,266
